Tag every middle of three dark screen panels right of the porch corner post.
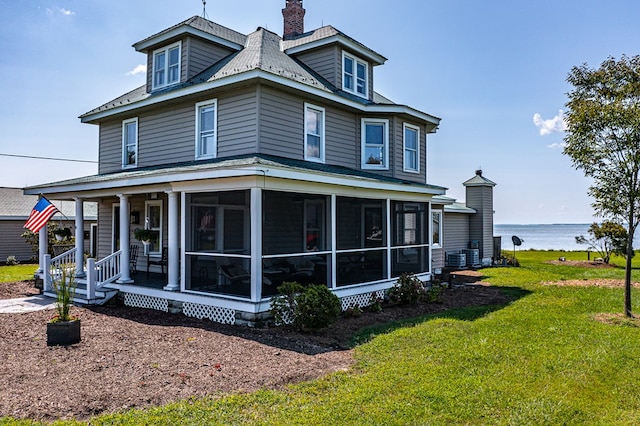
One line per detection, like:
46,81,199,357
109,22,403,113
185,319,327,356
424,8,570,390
336,197,387,286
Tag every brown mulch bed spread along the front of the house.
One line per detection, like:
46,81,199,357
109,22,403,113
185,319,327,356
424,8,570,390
0,276,509,421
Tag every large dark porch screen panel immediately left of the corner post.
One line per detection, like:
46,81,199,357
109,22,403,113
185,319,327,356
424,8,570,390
185,191,251,298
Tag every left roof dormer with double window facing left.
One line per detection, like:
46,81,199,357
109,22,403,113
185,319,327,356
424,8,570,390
133,16,247,93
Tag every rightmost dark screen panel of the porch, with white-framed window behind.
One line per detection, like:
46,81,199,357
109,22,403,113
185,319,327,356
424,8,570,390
391,201,430,277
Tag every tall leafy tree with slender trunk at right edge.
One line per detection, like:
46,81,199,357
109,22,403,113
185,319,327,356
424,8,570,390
564,56,640,317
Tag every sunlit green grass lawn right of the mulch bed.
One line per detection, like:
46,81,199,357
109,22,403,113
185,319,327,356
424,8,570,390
6,252,640,425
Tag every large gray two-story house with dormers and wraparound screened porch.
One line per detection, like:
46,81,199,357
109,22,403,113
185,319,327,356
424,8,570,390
25,0,493,323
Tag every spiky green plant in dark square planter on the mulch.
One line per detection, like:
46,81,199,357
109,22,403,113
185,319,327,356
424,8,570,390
47,265,80,346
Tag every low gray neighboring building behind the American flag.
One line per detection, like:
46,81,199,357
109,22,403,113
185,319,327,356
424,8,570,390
0,187,97,264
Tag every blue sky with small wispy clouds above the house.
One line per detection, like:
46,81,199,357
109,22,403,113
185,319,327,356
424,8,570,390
0,0,640,223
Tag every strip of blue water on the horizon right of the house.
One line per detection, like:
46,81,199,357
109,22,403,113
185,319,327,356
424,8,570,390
494,224,591,251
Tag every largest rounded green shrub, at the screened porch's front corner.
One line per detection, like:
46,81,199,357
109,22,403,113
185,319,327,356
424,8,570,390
271,282,341,330
